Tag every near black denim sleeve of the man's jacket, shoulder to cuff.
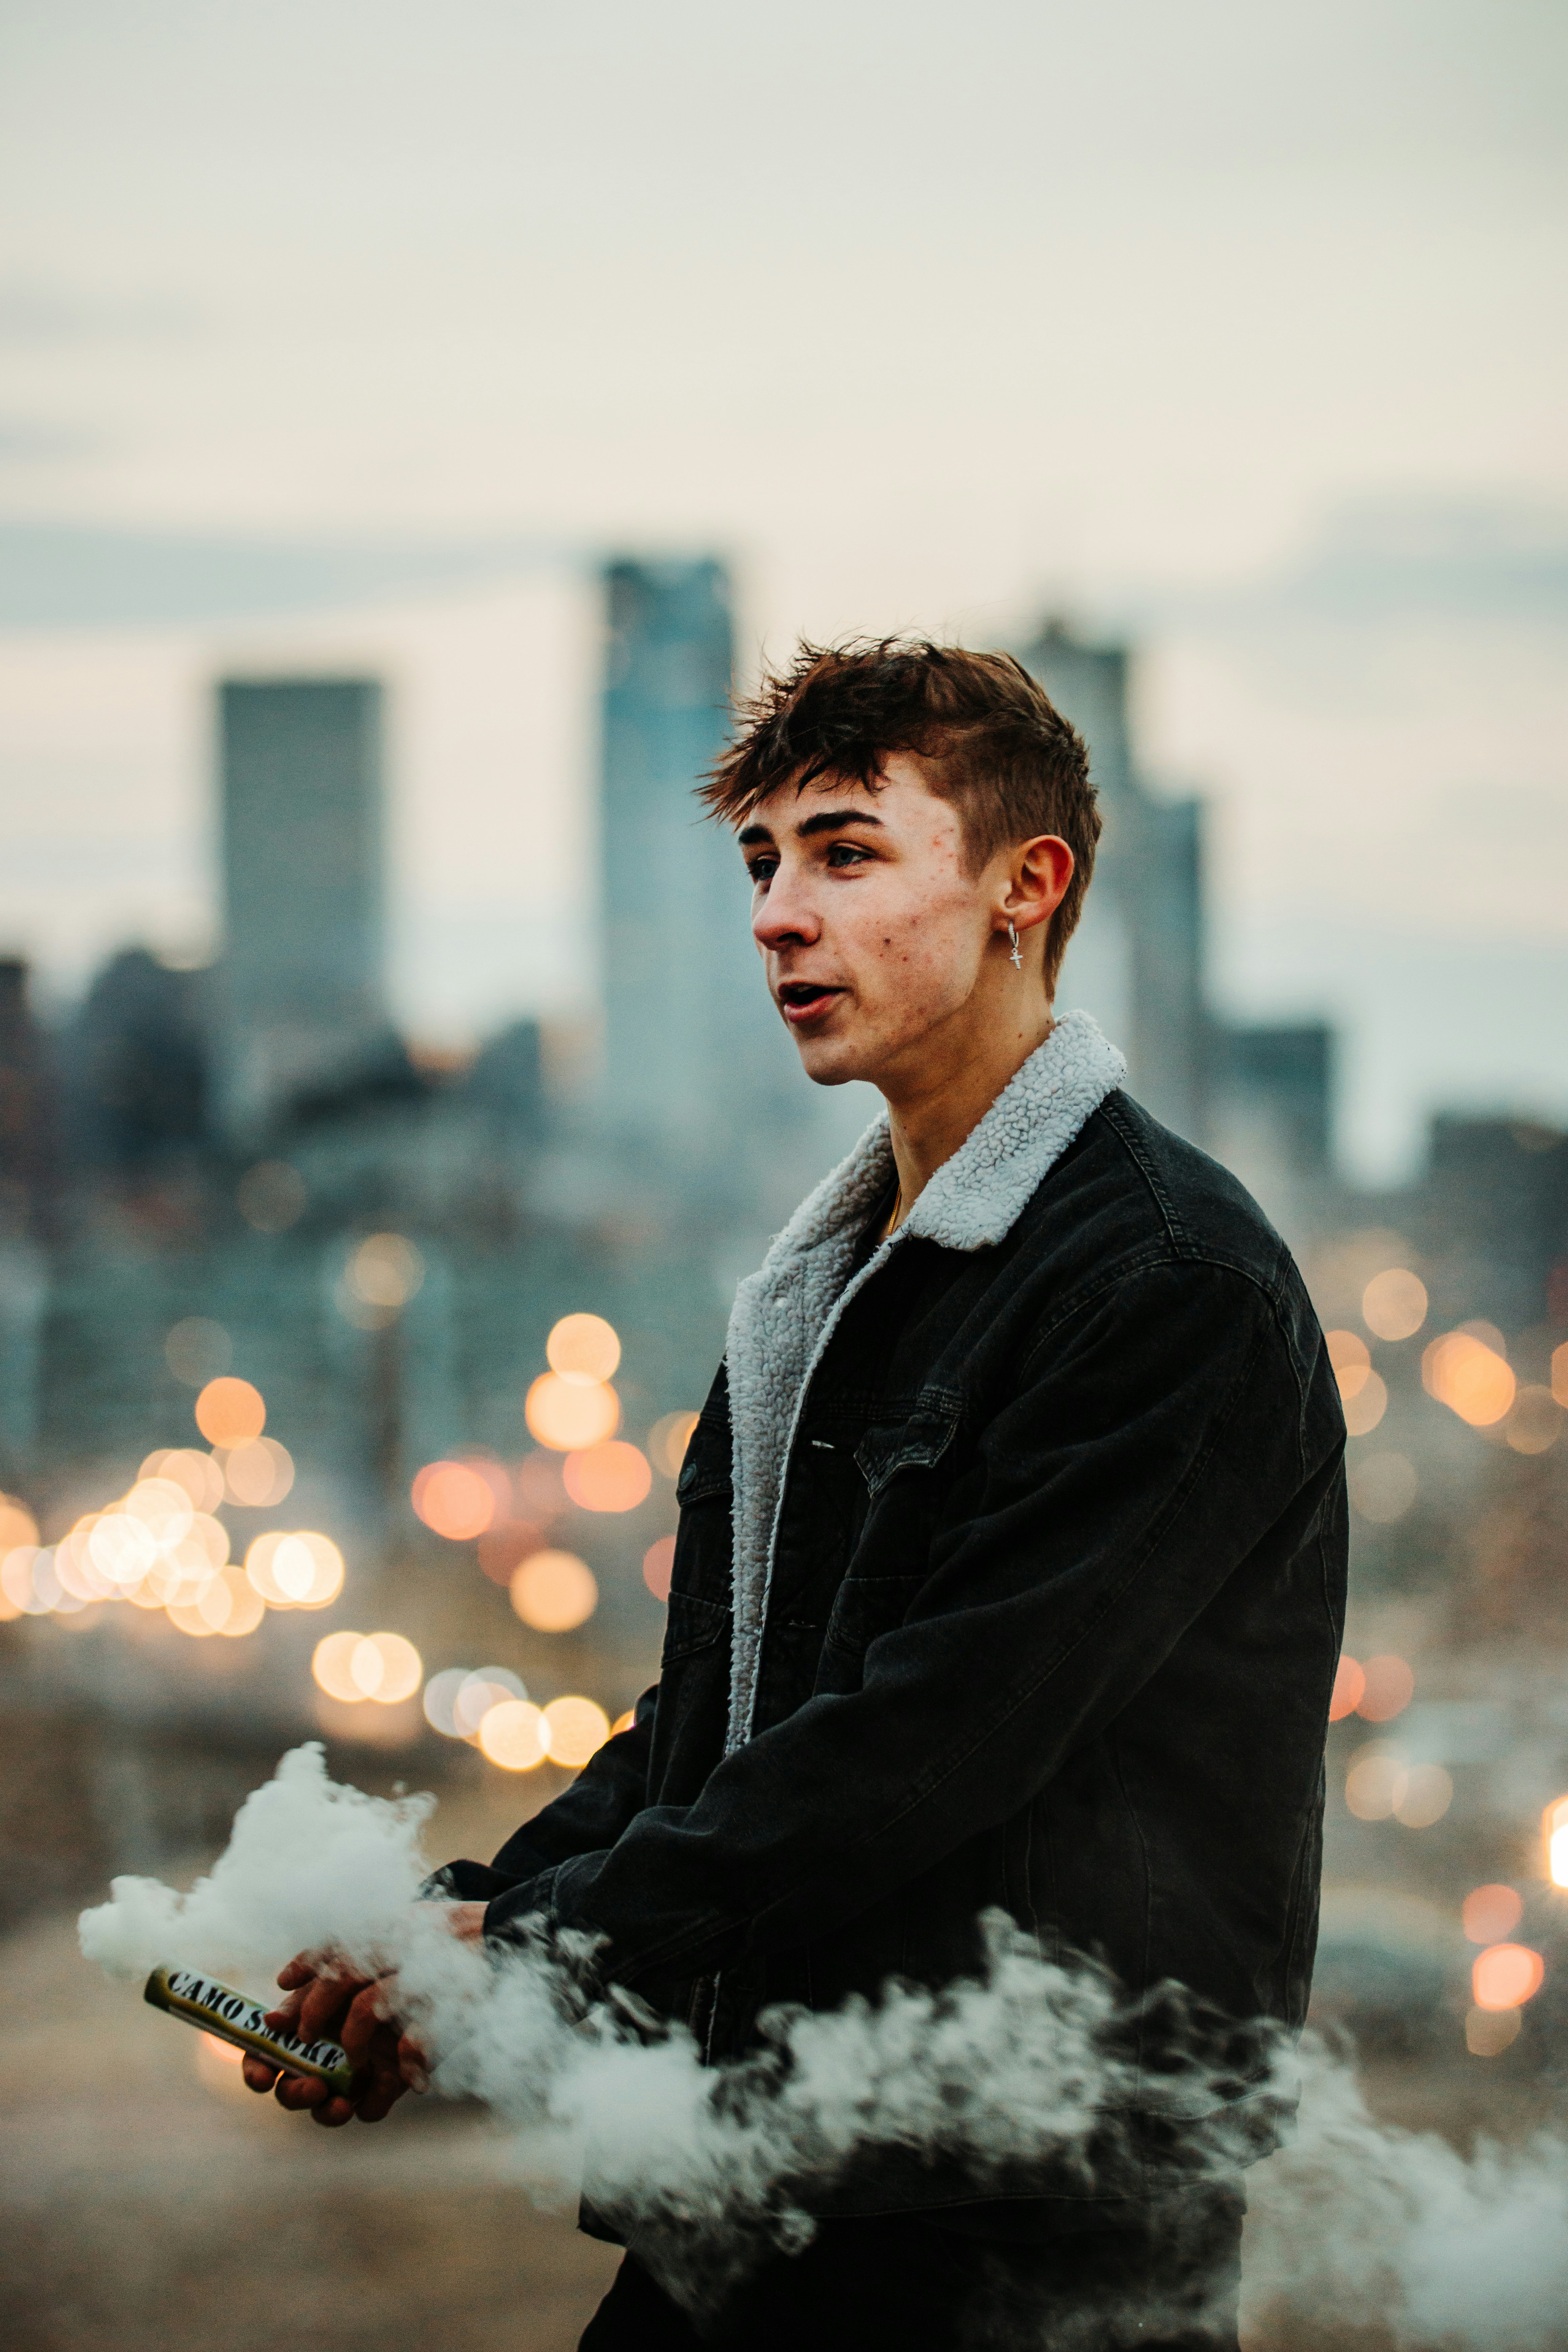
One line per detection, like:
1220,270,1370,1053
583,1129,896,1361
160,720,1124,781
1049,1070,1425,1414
487,1263,1342,1987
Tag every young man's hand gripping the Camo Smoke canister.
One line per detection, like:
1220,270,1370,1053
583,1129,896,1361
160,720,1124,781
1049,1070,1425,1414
242,1903,484,2129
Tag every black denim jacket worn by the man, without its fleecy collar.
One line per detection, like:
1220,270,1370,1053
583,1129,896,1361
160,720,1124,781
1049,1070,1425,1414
447,1091,1345,2204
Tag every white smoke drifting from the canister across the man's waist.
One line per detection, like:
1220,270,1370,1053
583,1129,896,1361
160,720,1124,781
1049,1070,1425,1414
82,1747,1568,2352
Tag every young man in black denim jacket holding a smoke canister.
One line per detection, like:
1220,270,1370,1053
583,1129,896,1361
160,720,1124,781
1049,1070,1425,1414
256,642,1345,2352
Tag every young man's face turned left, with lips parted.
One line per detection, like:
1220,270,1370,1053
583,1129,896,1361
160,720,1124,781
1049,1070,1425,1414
736,753,1018,1087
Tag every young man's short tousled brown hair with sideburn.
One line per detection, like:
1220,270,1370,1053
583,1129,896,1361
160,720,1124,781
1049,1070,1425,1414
698,637,1100,993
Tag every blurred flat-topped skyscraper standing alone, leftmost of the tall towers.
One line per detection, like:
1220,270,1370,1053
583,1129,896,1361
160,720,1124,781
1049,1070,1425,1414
216,677,388,1136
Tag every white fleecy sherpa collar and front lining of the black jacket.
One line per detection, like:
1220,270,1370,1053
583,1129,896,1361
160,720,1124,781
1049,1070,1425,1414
727,1014,1126,1750
